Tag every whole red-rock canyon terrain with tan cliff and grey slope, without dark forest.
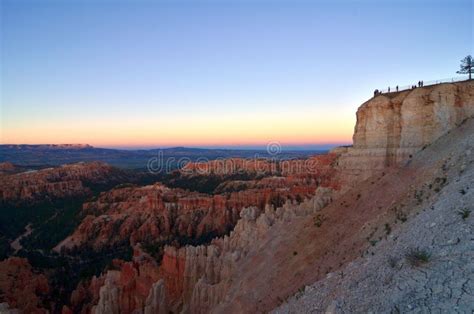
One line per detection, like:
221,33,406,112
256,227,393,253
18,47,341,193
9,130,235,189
0,81,474,313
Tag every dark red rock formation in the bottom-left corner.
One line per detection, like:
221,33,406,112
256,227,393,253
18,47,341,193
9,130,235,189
0,257,49,313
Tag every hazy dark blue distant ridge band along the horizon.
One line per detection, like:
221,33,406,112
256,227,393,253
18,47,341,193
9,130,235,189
0,144,327,170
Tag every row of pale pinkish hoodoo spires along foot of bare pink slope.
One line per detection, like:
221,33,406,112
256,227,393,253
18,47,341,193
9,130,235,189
135,188,332,313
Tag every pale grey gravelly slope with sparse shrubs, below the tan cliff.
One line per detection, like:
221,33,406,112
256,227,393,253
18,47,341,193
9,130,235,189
274,120,474,313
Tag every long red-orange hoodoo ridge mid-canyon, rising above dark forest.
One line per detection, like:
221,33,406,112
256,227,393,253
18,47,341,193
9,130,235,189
55,169,331,251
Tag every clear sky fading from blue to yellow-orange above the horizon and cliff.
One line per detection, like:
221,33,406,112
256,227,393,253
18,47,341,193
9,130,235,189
0,0,474,148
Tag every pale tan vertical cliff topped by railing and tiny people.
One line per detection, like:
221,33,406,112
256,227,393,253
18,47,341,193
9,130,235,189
338,81,474,185
